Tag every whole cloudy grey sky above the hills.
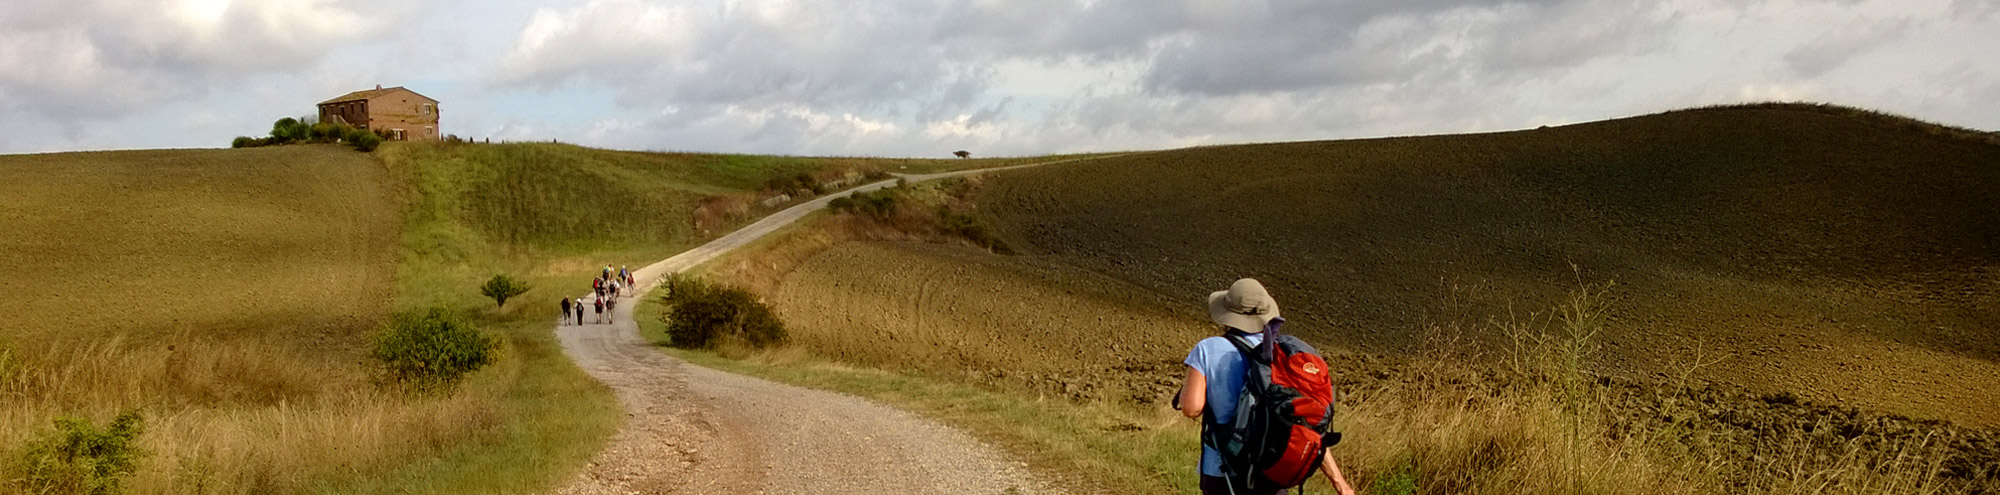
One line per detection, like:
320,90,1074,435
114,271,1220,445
0,0,2000,158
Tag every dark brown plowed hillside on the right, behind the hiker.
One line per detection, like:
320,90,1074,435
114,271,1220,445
980,108,2000,425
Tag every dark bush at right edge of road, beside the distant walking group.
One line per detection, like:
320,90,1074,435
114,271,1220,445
666,275,784,349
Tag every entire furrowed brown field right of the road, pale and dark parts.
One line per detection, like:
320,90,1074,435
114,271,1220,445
746,106,2000,493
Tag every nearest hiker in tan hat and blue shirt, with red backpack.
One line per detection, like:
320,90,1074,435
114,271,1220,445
1174,277,1354,495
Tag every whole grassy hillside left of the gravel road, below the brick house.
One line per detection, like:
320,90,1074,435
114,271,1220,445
0,144,1006,493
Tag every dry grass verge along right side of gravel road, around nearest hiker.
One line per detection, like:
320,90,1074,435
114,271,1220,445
652,261,1952,495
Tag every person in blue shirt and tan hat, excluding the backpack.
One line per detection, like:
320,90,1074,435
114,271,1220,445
1174,279,1354,495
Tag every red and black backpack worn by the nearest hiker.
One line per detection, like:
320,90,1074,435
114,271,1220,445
1202,325,1340,493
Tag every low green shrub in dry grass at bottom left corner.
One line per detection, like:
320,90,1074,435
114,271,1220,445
16,411,146,495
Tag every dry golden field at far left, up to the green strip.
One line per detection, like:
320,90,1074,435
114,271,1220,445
0,146,436,493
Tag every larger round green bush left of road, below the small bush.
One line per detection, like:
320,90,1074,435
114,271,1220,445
374,307,500,389
